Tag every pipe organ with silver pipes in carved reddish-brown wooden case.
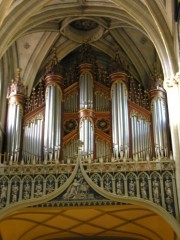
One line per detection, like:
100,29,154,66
5,45,171,164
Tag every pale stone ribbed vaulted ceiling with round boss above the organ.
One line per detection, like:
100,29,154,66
0,0,177,96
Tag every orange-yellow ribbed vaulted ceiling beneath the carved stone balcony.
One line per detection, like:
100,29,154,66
0,205,178,240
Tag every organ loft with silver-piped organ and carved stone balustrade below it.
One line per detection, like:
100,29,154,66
0,44,179,232
